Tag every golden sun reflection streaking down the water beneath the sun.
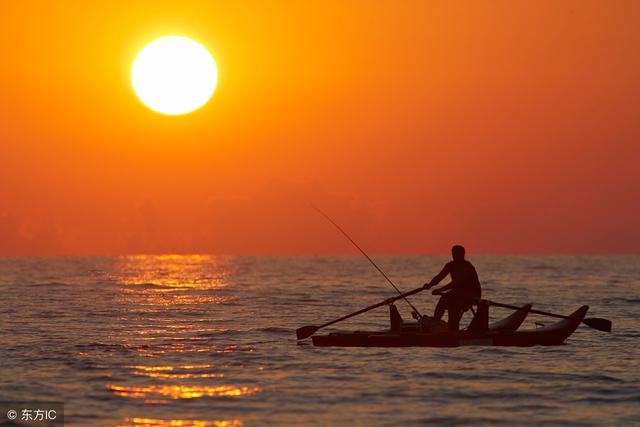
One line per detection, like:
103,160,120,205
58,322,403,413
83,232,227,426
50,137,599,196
105,255,262,420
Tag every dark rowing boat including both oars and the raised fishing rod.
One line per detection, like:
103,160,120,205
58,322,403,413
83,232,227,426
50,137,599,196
295,214,612,347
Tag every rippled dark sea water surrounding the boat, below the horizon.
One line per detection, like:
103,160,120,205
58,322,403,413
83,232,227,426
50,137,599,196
0,256,640,427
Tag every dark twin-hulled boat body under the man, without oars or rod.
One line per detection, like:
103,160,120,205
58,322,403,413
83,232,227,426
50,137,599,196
311,304,589,347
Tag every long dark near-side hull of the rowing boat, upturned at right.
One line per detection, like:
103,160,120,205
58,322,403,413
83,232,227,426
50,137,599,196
312,306,589,347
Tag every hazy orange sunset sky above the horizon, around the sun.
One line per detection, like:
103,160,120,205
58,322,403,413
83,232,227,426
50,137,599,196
0,0,640,255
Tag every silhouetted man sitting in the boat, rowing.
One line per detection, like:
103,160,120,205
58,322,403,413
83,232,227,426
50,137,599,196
424,245,482,332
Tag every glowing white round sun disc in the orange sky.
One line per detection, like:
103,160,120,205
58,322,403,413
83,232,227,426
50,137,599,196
131,36,218,115
